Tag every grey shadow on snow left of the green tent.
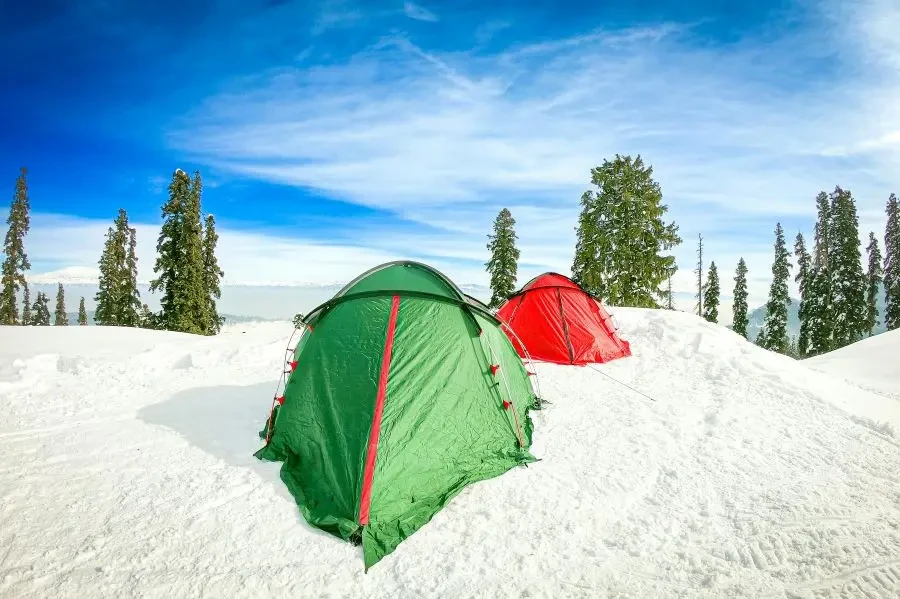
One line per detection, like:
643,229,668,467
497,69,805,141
138,381,298,508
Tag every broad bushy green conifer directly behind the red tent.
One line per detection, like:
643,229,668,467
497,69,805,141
572,154,681,308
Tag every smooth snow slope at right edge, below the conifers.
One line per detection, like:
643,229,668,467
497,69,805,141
805,330,900,400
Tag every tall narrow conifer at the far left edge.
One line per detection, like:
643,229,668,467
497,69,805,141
0,167,31,325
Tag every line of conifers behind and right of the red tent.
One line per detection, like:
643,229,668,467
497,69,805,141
485,154,900,358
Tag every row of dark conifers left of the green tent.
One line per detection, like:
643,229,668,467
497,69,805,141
0,167,225,335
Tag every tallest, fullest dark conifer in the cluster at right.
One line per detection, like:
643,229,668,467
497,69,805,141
828,186,866,349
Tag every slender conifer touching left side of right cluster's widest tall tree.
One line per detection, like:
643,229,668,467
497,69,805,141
805,191,833,356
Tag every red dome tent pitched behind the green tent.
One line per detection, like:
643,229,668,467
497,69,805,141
497,272,631,365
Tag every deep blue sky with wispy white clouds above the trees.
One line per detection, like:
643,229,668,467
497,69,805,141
0,0,900,314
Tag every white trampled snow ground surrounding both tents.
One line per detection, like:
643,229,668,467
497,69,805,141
0,309,900,599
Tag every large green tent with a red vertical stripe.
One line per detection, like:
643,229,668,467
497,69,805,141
255,261,537,570
